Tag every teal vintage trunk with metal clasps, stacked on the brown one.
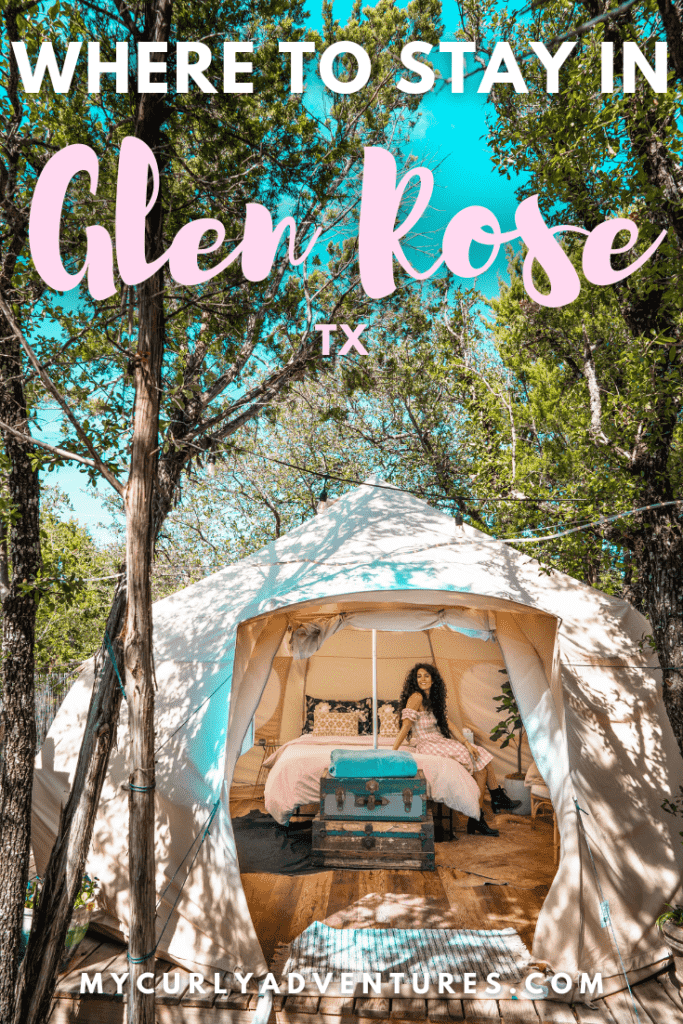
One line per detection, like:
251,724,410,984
321,771,428,821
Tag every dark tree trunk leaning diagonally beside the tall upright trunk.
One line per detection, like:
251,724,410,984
14,574,126,1024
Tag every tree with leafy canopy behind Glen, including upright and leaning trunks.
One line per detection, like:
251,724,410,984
6,0,438,1022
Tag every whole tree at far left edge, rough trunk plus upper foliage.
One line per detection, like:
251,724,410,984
0,2,77,1007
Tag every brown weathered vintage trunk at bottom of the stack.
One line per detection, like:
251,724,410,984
312,814,434,871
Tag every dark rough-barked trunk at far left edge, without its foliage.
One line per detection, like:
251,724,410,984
0,332,40,1021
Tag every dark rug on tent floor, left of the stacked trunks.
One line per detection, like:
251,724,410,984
232,810,321,874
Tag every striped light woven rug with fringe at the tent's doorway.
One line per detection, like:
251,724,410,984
271,921,530,986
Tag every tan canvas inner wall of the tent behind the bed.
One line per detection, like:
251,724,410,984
232,607,557,785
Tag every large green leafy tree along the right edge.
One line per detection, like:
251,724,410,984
446,0,683,753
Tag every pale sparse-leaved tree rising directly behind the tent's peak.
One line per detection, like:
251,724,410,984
139,284,497,596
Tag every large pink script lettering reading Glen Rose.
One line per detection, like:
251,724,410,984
29,137,667,307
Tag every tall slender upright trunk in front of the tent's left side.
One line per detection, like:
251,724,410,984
124,0,173,1024
